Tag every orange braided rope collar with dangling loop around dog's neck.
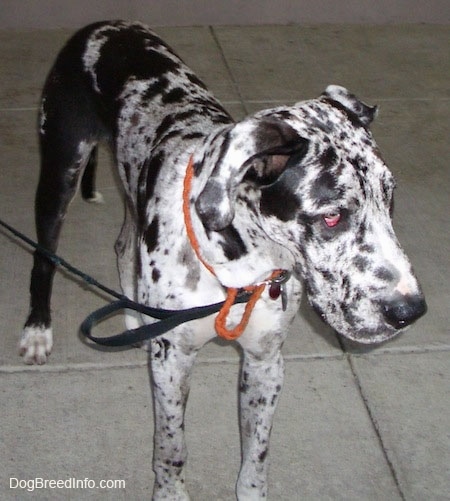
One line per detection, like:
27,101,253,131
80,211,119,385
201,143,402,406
183,156,272,341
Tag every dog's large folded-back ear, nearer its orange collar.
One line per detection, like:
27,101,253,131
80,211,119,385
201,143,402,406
195,117,308,231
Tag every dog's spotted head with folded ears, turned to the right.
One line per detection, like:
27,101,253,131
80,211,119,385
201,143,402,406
192,86,426,343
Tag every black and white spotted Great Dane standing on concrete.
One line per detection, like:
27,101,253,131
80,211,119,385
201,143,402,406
20,21,426,500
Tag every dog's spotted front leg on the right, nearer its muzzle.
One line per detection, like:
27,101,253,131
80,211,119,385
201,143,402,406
236,347,284,501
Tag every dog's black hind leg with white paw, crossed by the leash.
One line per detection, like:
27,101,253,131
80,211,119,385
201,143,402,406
19,66,102,364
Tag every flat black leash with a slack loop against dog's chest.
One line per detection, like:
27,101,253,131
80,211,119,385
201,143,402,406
0,219,251,346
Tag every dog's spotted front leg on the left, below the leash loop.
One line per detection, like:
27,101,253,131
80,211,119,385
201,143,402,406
151,337,197,501
